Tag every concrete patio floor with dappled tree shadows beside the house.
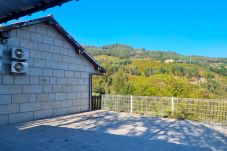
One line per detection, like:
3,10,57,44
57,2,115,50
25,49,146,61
0,111,227,151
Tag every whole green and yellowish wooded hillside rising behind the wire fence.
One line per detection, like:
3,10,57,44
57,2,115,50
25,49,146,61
85,44,227,98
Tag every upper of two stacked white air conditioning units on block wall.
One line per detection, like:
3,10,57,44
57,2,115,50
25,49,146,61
12,48,28,60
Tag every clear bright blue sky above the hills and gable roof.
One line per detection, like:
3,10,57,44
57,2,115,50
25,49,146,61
8,0,227,57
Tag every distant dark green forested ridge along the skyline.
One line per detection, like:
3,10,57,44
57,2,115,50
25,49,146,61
84,44,227,76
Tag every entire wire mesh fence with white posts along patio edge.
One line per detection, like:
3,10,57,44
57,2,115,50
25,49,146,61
102,95,227,125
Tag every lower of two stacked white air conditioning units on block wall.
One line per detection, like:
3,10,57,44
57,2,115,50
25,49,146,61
11,61,28,73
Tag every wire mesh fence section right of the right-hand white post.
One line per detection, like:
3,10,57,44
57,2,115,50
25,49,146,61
174,98,227,125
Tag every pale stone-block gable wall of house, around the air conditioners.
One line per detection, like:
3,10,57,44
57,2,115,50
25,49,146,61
0,23,96,125
